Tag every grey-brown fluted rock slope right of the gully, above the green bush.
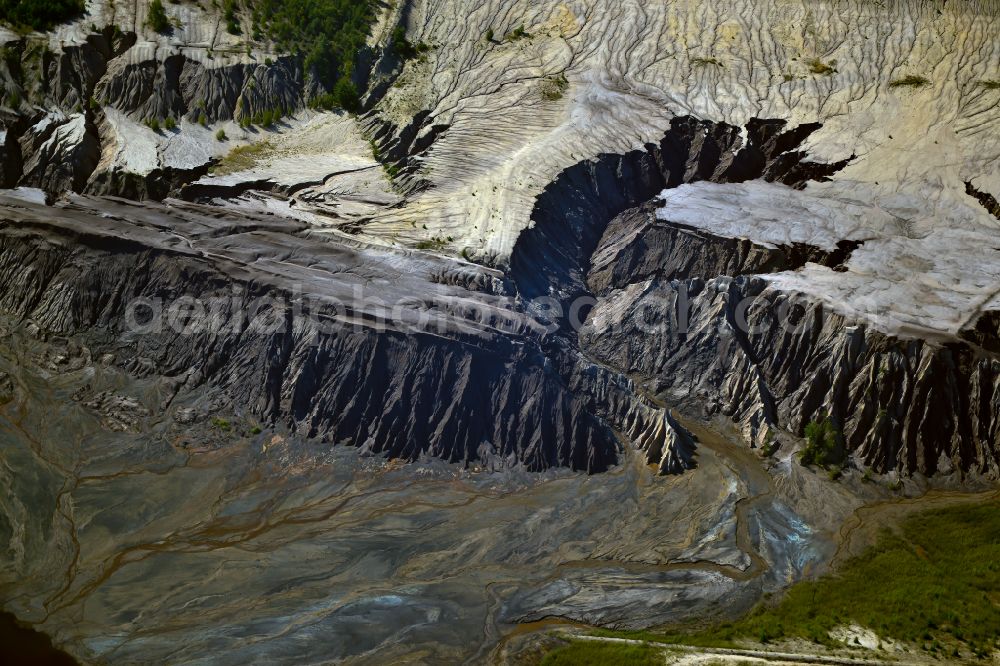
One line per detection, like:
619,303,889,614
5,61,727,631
582,277,1000,476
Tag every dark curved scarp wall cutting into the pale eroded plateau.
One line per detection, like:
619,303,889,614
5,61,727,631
510,117,850,297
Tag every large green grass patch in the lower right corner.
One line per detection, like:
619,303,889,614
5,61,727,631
580,501,1000,658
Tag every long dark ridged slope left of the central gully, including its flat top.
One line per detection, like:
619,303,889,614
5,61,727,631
0,192,704,472
